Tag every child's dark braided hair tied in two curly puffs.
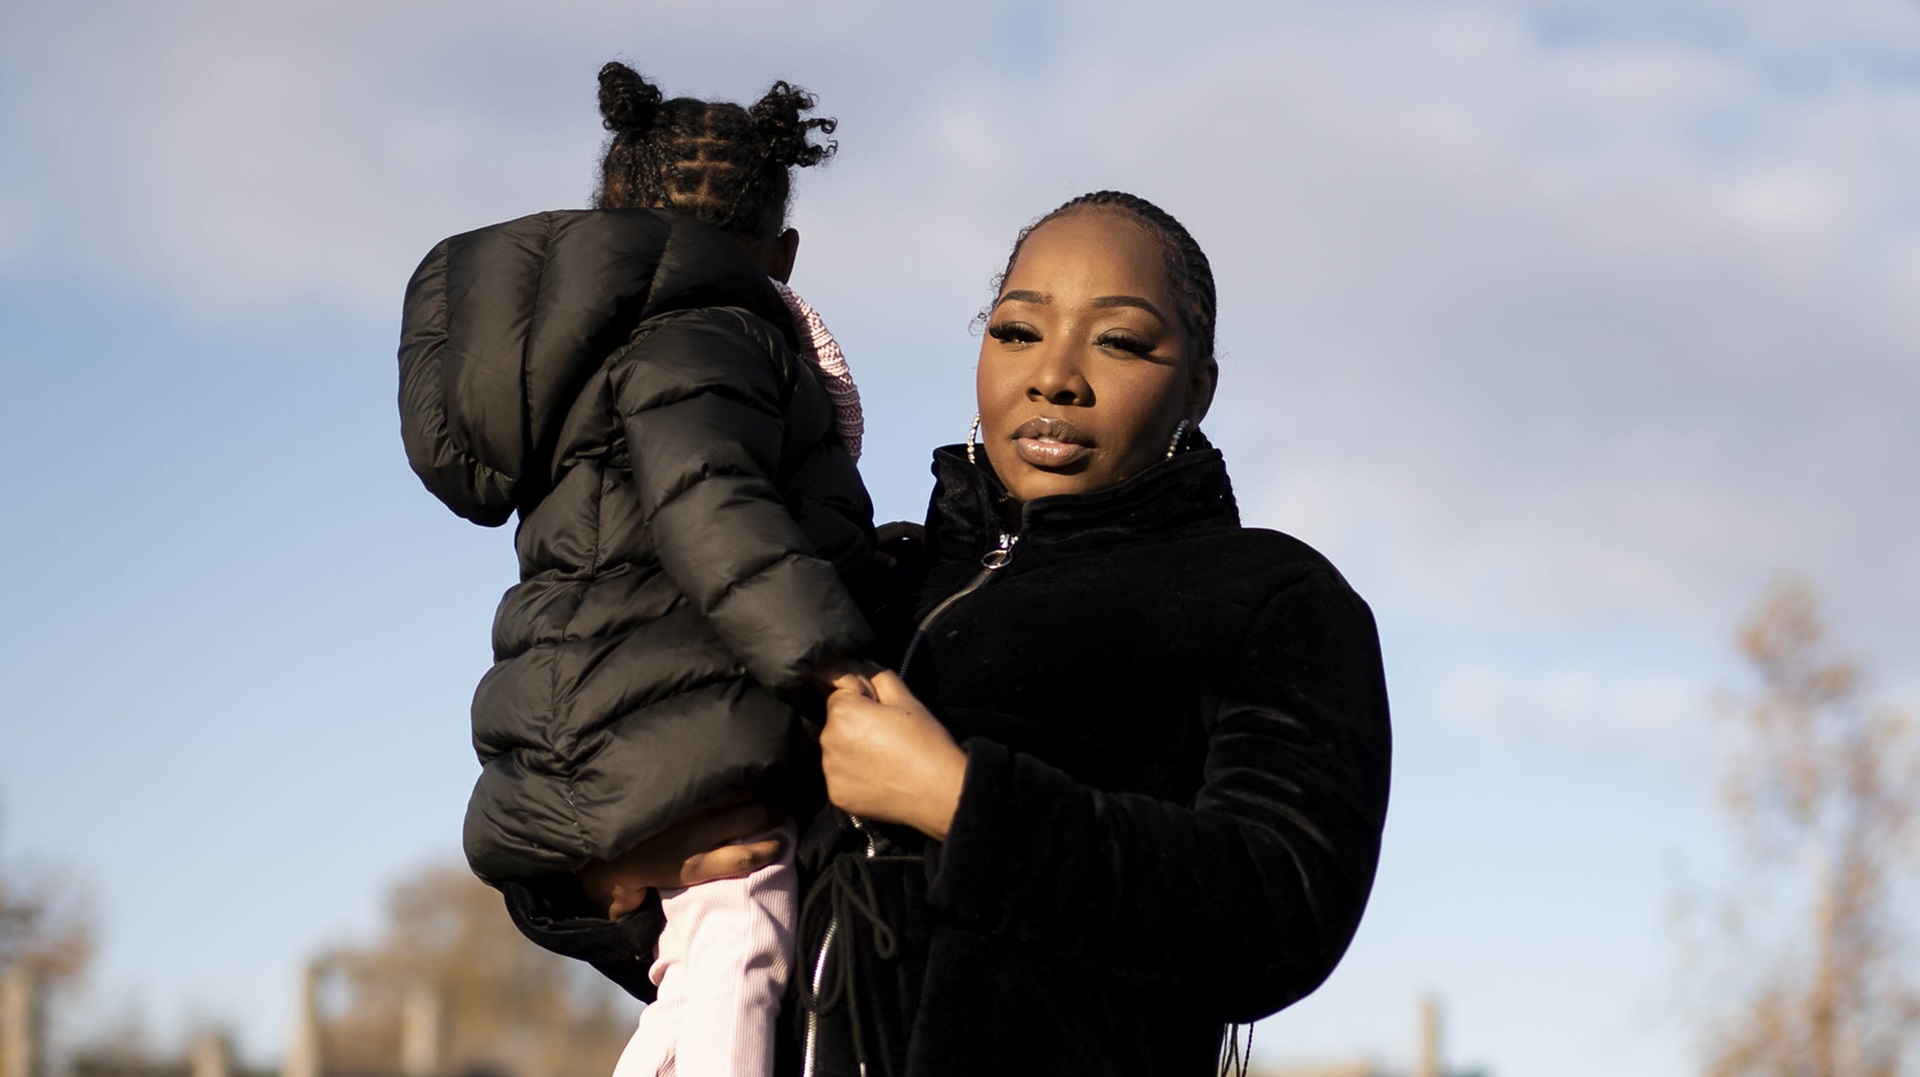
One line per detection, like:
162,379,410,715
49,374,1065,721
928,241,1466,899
593,61,839,242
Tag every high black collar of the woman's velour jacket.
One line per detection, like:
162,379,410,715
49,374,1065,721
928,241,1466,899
927,432,1240,561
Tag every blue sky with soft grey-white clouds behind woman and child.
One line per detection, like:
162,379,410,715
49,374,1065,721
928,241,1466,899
0,0,1920,1077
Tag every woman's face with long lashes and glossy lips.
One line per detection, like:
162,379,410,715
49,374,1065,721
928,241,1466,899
975,209,1217,501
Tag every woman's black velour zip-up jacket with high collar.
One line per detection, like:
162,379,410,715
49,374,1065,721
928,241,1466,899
781,442,1390,1077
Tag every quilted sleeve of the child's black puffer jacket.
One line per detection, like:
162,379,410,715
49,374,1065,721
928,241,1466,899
611,307,872,689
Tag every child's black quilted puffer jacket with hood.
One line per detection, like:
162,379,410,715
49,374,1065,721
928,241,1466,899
399,209,874,895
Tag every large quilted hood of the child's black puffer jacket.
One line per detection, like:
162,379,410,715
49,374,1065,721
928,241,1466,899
399,209,797,526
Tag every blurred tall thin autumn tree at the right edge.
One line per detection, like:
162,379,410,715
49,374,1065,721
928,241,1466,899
1707,582,1920,1077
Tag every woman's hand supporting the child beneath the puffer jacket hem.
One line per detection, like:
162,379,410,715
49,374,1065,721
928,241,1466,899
578,793,781,920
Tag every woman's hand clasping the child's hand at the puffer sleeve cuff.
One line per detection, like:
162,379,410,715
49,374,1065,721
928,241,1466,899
820,670,966,841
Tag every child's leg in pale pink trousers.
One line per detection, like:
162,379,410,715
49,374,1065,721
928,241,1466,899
614,824,799,1077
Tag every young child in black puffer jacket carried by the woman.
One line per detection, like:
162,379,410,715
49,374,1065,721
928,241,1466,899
399,63,874,1077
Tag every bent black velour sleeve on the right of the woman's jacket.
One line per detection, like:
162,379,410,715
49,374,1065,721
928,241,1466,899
927,572,1390,1021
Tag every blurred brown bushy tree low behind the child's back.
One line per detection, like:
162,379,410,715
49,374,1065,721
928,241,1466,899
321,866,639,1077
